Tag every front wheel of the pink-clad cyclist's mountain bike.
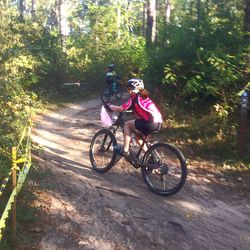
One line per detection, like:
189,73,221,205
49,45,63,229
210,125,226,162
89,129,117,173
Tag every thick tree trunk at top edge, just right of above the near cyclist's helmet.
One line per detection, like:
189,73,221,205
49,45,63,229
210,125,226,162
146,0,156,45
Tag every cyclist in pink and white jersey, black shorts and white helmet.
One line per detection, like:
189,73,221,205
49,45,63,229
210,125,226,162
107,78,162,159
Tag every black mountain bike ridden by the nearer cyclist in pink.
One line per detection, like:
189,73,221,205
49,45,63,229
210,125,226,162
89,112,187,196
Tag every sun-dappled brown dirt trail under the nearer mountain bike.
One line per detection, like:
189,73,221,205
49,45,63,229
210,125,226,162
30,97,250,250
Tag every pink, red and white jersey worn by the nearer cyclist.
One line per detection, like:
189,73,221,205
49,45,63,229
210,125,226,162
122,95,162,123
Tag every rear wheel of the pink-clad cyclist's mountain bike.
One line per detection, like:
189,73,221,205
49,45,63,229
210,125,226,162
142,143,187,196
